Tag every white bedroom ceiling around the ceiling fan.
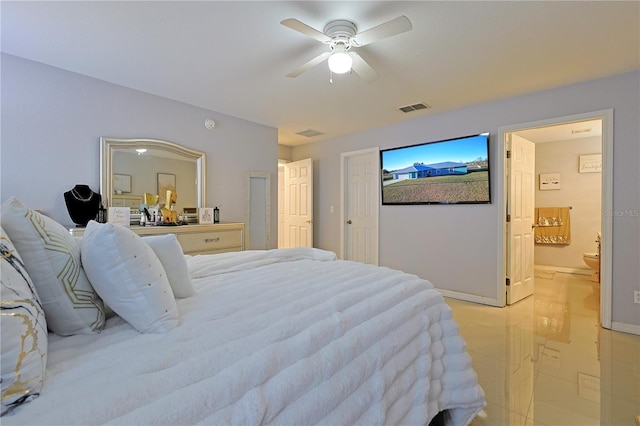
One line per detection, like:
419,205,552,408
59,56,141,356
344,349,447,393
0,0,640,145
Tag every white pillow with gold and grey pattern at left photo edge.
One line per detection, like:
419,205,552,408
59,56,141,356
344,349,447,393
0,229,47,415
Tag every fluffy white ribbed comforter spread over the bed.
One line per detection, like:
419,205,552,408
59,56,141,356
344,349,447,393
2,249,485,425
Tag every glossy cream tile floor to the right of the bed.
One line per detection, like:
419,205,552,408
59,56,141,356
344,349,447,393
446,271,640,426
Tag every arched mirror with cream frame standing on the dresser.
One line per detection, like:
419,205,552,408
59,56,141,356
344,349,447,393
100,137,206,214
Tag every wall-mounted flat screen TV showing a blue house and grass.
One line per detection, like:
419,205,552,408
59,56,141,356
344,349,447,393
380,133,491,205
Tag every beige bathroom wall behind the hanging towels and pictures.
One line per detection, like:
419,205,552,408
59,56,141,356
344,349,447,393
535,137,602,269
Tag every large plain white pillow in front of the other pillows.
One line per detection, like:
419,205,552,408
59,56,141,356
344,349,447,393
82,220,179,333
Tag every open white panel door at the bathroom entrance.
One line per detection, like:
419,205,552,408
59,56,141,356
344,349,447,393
506,133,536,305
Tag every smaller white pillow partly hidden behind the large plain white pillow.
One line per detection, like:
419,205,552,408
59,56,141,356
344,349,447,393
142,234,196,299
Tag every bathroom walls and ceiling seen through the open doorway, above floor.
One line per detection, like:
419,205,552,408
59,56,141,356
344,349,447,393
515,119,602,276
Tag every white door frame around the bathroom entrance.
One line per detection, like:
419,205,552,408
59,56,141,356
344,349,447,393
495,109,613,329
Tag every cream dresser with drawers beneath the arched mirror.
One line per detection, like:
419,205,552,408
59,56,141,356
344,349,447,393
69,222,244,255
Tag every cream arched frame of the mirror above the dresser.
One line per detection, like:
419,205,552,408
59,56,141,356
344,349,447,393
100,137,207,208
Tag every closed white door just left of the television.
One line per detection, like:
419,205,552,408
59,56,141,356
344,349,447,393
342,149,380,265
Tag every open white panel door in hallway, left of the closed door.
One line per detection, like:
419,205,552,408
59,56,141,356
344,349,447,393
283,158,313,247
